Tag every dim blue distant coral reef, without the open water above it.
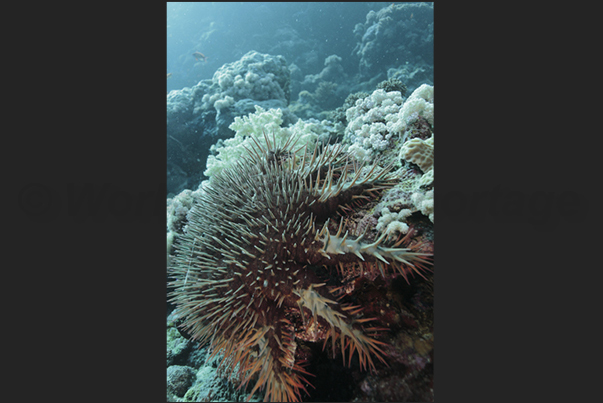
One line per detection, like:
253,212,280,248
166,3,433,195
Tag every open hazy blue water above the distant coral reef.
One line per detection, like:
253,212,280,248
166,2,433,91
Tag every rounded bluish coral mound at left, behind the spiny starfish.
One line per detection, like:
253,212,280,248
166,51,297,194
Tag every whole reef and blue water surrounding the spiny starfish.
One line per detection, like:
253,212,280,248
166,2,434,401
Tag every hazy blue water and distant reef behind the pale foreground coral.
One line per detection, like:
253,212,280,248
166,2,434,195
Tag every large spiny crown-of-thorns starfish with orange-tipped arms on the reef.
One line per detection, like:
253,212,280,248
169,134,429,401
